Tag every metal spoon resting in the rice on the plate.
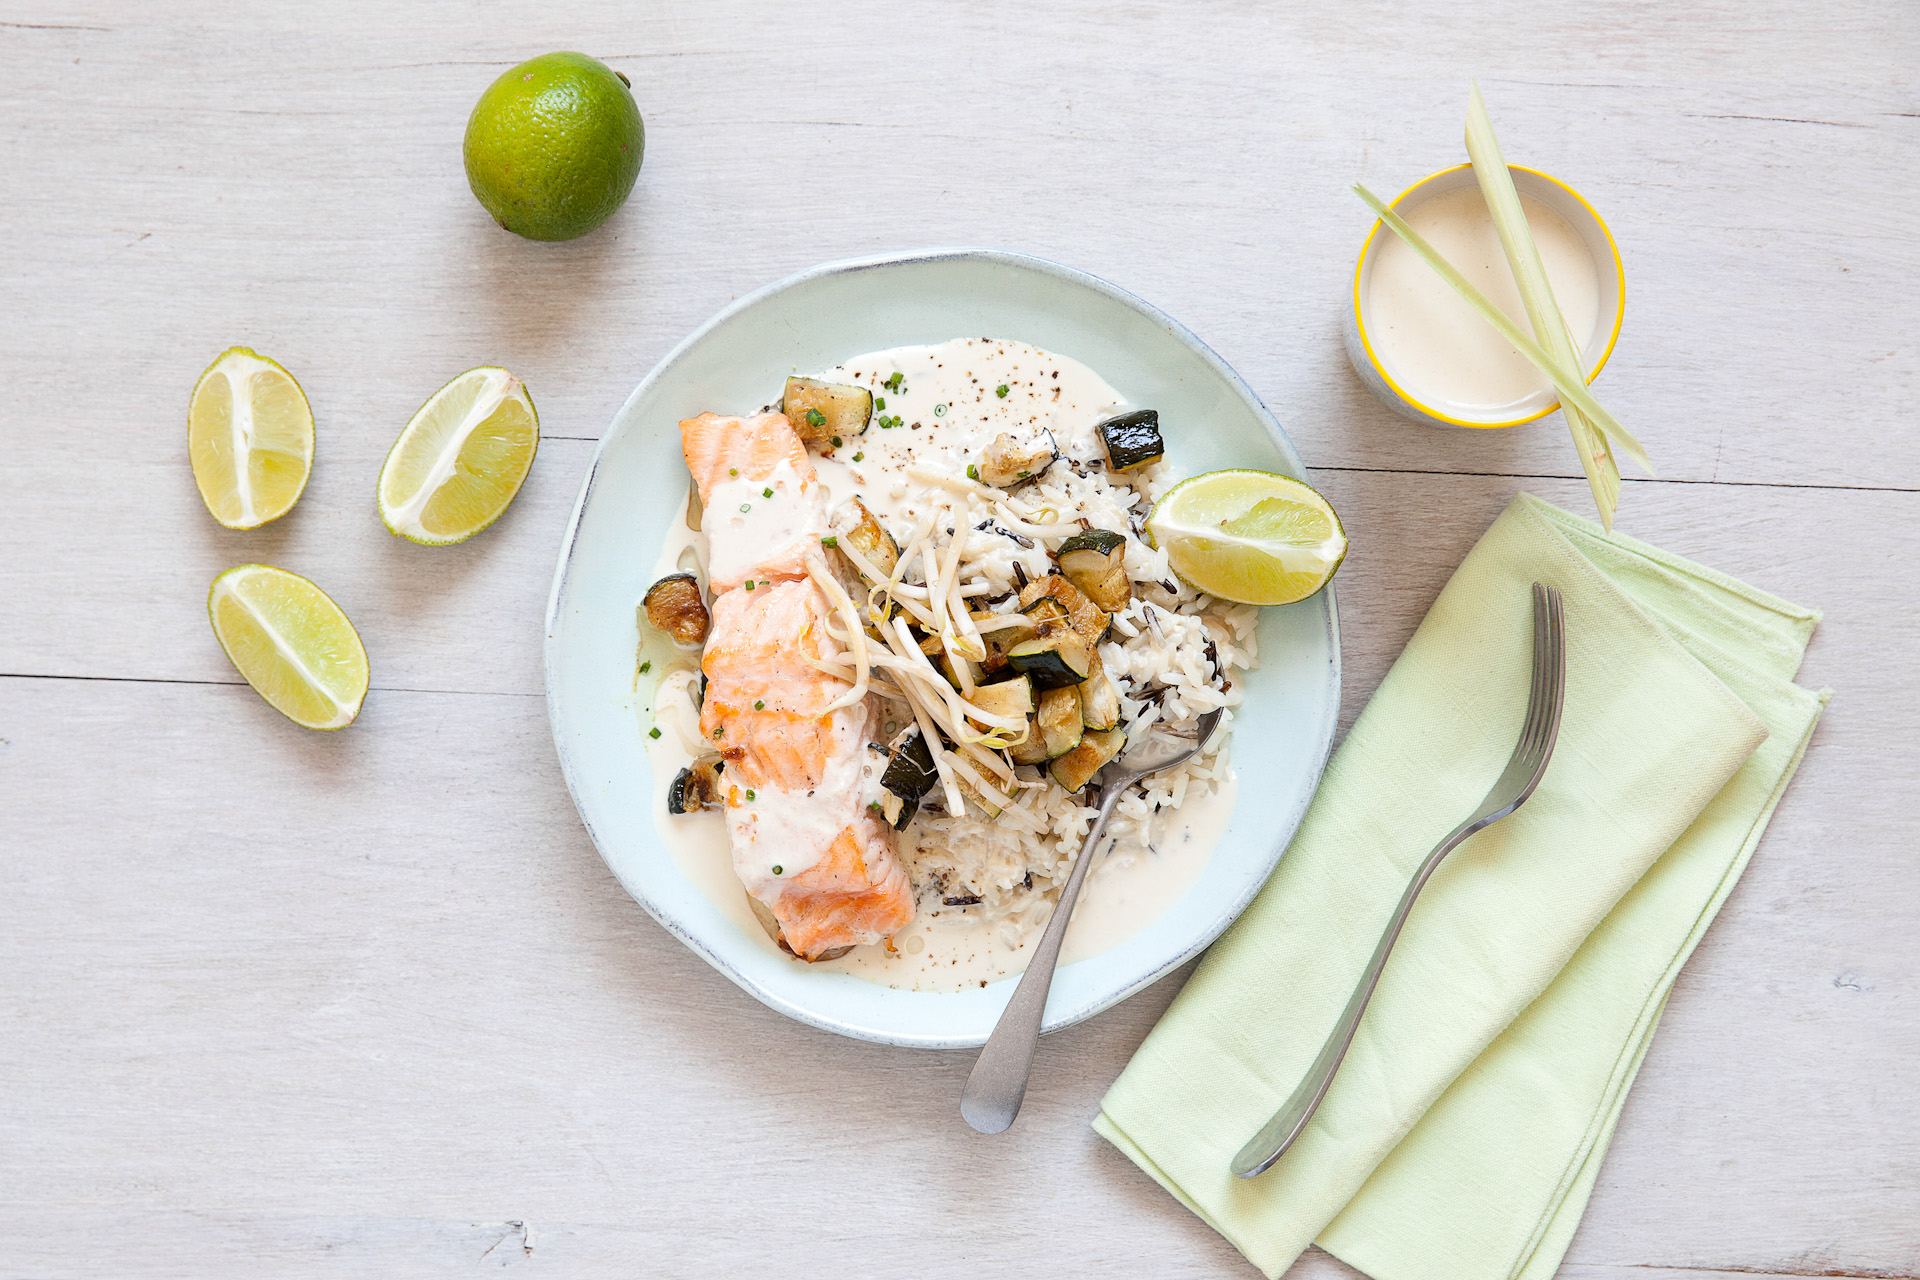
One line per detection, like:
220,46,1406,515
960,710,1219,1134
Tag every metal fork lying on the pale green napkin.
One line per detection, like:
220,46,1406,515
1231,581,1567,1178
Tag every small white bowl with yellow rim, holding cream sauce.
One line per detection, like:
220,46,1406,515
1346,165,1626,428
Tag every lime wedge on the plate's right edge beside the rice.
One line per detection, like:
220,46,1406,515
1146,470,1346,604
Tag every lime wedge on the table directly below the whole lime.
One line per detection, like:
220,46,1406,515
380,367,540,547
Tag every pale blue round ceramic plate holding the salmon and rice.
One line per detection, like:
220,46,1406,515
545,249,1340,1048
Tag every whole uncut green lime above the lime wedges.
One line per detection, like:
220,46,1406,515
463,54,647,240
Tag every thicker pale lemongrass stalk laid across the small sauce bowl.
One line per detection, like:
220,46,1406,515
1467,83,1620,533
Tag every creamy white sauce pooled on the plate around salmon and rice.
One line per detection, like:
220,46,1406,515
636,340,1235,990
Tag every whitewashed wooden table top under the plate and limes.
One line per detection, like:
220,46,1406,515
0,0,1920,1280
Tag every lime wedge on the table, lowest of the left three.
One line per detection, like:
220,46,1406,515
207,564,367,729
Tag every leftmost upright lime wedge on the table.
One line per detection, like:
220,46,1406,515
186,347,313,530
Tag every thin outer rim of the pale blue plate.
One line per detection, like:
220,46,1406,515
541,246,1342,1050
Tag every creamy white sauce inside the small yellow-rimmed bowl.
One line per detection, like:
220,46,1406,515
1367,186,1599,411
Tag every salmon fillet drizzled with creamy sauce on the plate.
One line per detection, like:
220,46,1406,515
680,413,914,960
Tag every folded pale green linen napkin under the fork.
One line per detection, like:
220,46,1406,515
1094,493,1824,1280
